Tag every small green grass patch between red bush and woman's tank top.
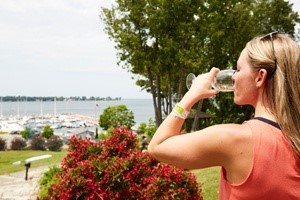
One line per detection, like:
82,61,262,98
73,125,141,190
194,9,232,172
193,167,220,200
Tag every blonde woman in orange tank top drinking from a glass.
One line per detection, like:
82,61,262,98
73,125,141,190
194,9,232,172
148,32,300,200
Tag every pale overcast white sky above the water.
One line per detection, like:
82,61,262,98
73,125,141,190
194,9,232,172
0,0,300,99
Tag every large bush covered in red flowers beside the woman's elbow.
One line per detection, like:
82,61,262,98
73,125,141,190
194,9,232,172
47,128,202,200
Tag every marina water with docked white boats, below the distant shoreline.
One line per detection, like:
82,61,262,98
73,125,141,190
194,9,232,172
0,99,154,141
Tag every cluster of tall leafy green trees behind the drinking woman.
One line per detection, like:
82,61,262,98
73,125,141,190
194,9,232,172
101,0,300,126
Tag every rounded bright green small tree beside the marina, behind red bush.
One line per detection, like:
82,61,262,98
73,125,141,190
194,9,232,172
99,105,135,130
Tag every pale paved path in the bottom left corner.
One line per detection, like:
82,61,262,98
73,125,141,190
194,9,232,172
0,166,49,200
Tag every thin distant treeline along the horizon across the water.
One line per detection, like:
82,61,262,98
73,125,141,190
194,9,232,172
0,96,121,101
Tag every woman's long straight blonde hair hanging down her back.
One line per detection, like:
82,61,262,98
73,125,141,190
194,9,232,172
246,33,300,155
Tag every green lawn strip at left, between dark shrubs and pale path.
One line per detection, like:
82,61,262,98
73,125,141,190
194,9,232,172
0,149,68,175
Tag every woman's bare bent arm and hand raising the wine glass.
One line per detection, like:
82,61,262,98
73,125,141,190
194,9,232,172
148,68,253,169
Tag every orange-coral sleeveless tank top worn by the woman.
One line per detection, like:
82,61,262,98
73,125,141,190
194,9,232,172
219,118,300,200
